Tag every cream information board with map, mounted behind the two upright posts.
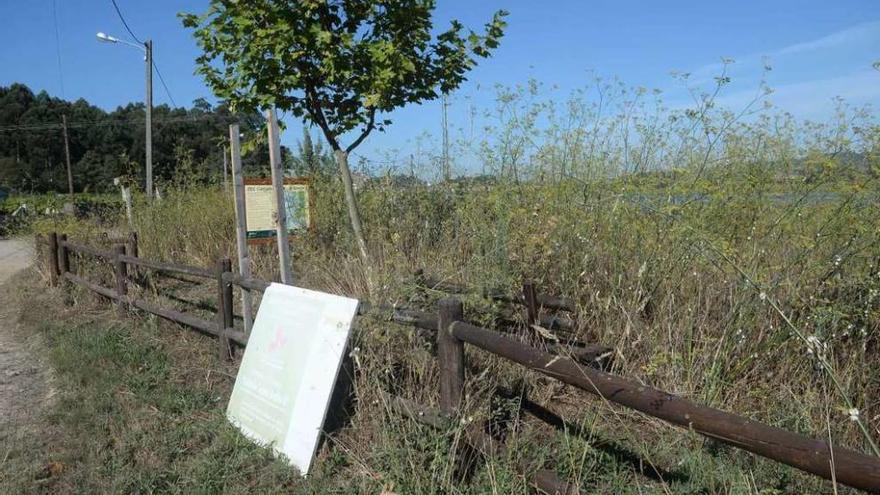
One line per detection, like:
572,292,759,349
244,178,314,243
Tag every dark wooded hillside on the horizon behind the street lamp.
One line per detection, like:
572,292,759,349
0,83,300,193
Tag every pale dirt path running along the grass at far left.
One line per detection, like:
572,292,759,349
0,239,49,438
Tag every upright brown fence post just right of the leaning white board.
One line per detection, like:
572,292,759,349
437,298,464,415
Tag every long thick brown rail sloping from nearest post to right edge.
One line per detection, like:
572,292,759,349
445,321,880,492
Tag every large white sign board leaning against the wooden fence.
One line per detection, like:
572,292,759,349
226,284,358,475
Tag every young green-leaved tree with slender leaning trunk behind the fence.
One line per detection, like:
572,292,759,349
181,0,507,265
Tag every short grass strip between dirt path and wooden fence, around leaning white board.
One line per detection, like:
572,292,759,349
0,274,526,494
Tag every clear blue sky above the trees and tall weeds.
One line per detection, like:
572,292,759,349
0,0,880,167
